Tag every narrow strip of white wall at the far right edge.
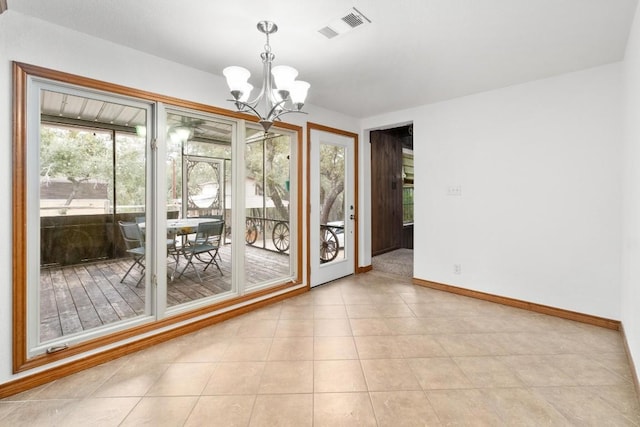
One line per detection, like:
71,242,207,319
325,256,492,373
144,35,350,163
622,8,640,382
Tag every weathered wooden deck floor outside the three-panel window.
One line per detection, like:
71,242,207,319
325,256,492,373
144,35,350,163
40,245,289,342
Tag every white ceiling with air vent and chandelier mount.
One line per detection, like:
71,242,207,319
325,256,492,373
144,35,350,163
8,0,637,117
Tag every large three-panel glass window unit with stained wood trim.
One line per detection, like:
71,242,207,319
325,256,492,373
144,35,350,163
13,66,302,371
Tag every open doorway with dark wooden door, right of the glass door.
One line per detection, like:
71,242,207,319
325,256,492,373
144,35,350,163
369,124,414,277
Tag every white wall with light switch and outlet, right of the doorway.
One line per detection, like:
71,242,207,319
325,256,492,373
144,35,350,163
363,63,622,319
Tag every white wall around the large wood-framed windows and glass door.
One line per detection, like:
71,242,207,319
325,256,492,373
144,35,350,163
0,10,359,384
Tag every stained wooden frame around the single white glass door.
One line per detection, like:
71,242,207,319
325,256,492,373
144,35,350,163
306,122,360,287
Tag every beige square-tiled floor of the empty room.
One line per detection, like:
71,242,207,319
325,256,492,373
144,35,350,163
0,271,640,427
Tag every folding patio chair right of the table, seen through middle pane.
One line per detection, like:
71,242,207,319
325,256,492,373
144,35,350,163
178,221,224,282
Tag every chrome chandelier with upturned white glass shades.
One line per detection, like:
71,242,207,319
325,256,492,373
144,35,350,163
222,21,311,132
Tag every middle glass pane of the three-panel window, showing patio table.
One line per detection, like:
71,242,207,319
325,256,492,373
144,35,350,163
166,112,233,307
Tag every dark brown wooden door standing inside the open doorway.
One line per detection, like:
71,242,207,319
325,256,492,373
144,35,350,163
370,131,402,256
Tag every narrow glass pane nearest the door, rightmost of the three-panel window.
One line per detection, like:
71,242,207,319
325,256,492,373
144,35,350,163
245,129,291,288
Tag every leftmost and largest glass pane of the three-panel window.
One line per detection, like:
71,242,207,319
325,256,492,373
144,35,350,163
38,90,147,343
